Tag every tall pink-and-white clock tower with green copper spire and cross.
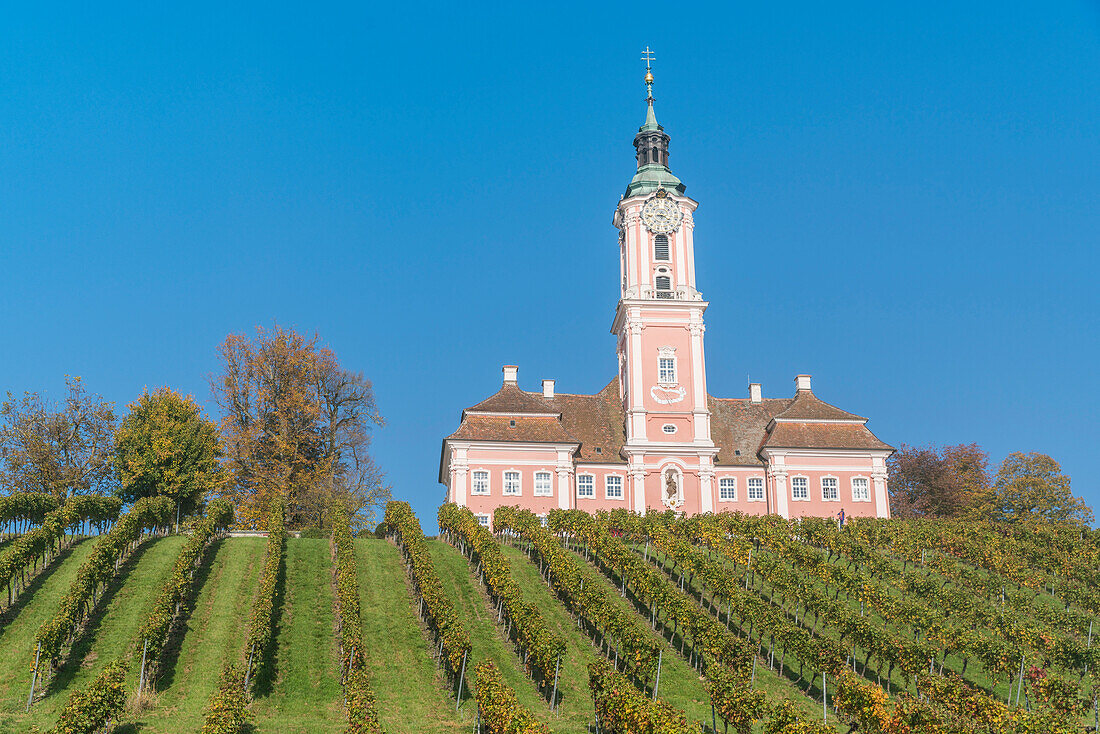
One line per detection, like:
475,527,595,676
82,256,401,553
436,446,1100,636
612,47,717,512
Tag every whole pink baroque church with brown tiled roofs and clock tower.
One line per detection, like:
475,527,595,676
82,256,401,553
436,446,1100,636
439,73,893,524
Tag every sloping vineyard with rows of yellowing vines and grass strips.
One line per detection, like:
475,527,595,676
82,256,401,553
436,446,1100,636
0,495,1100,734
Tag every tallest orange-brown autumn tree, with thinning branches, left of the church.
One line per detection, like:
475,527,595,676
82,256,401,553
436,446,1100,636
213,326,388,527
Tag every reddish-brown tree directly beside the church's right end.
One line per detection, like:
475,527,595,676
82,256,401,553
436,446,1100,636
888,443,990,518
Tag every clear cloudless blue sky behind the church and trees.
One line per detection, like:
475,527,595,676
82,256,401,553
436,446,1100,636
0,1,1100,530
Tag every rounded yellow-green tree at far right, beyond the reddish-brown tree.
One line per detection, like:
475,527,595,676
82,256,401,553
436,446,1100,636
982,451,1092,525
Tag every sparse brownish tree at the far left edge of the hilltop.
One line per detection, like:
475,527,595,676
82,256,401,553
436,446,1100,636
0,377,114,500
